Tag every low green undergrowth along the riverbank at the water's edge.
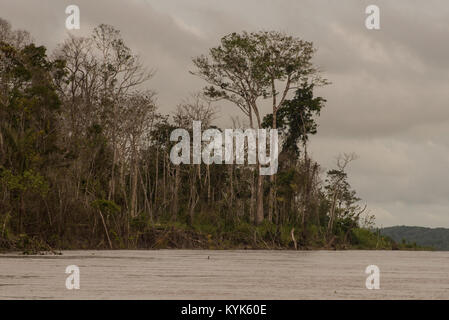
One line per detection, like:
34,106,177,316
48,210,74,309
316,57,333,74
0,223,432,254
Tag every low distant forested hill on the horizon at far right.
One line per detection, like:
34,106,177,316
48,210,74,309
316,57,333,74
380,226,449,250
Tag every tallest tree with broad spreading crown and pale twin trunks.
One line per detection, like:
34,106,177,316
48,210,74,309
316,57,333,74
193,31,326,223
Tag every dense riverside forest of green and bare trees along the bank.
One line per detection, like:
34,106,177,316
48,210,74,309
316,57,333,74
0,19,406,252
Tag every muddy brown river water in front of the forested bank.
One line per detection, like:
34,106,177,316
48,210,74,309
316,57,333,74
0,250,449,300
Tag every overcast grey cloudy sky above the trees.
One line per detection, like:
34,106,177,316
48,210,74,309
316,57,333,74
0,0,449,227
